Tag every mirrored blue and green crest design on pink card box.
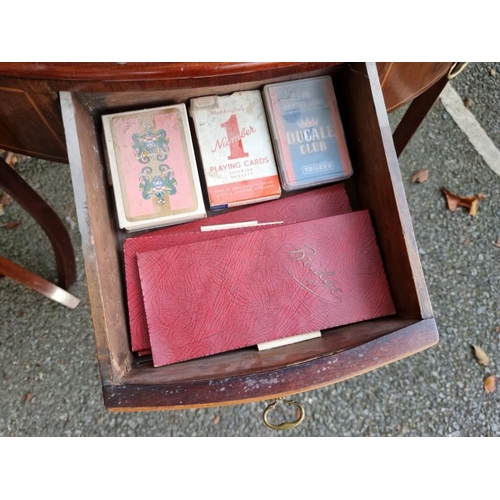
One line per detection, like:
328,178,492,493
132,127,177,205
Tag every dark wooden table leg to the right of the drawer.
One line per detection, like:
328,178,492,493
392,75,448,156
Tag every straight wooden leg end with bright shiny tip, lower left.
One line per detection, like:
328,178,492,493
0,255,80,309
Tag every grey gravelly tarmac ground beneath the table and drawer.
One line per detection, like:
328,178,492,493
0,63,500,436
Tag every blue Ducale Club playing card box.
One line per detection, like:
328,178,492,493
263,76,352,191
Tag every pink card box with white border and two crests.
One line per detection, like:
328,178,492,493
102,104,206,231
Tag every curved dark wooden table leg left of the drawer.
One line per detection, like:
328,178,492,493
0,158,76,289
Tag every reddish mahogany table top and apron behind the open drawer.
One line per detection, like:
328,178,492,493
0,62,451,163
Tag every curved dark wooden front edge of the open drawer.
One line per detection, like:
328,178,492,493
103,319,438,411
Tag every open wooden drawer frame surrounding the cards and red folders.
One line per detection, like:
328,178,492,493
61,63,438,410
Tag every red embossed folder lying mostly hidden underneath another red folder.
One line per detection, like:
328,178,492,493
123,184,351,354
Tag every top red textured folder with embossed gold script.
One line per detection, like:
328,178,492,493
137,210,395,366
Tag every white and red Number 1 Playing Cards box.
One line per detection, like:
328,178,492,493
190,90,281,209
